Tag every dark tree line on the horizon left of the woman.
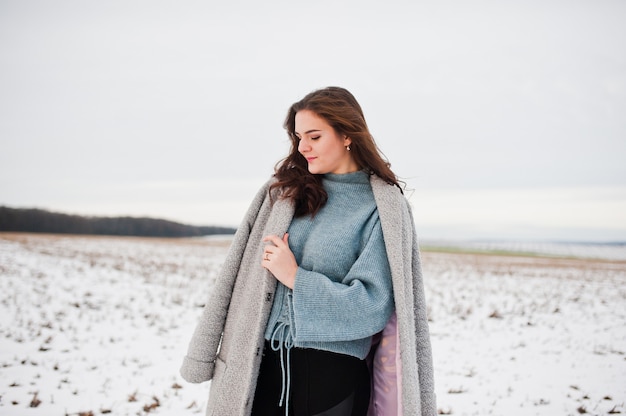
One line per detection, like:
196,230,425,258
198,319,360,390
0,206,236,237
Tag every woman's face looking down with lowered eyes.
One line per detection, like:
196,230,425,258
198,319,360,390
295,110,358,174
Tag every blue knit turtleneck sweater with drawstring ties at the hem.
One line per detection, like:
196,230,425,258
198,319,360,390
265,171,393,359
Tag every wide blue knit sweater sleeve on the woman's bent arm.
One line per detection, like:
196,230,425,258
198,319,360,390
293,221,393,342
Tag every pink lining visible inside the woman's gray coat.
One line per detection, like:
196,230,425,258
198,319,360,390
367,312,402,416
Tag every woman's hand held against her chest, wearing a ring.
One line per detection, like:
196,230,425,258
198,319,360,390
261,233,298,289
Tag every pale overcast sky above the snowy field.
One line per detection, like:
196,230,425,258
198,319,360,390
0,0,626,240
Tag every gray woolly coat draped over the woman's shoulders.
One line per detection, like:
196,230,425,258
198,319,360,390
181,175,437,416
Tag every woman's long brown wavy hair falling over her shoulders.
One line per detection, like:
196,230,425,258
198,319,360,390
270,87,402,216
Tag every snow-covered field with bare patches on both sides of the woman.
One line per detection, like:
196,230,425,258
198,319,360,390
0,233,626,416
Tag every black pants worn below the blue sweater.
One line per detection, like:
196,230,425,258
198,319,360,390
252,342,370,416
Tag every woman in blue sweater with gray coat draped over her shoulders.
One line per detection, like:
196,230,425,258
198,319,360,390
181,87,436,416
